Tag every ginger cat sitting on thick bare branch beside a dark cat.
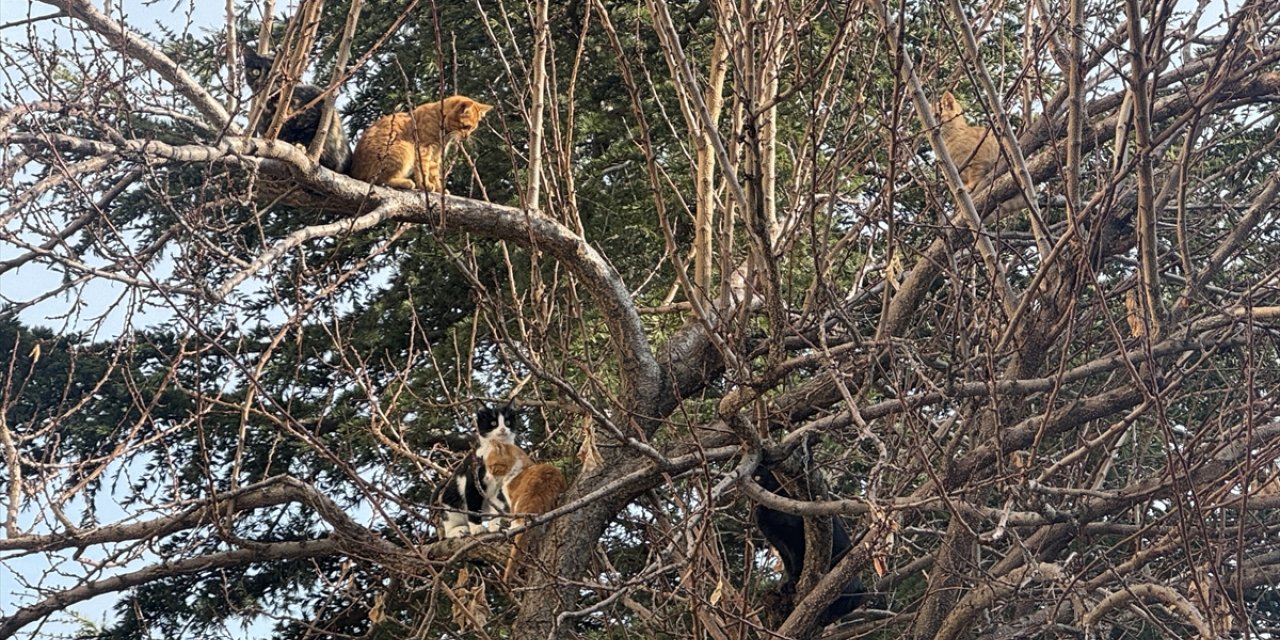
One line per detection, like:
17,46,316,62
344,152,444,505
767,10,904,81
351,96,493,192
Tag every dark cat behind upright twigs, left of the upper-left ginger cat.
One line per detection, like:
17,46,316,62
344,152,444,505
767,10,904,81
243,47,351,173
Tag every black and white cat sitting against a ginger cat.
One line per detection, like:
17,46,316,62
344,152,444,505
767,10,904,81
440,406,516,538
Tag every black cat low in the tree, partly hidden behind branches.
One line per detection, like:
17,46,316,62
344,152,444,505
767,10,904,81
754,465,867,625
